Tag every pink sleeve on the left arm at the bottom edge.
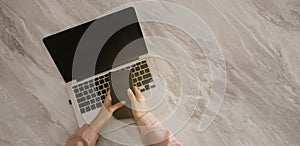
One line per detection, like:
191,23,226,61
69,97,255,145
66,124,99,146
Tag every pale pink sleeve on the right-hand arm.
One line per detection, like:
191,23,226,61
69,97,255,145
137,113,182,146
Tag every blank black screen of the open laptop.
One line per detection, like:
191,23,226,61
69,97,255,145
43,7,148,82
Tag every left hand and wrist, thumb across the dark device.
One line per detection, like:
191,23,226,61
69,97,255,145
90,90,126,132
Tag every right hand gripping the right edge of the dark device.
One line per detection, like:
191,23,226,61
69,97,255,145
127,87,147,121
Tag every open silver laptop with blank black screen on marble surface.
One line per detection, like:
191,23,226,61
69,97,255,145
43,7,155,126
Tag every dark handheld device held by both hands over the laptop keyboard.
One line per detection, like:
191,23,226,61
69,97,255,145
109,70,133,119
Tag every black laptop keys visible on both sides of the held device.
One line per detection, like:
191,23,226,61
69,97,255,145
72,60,155,114
